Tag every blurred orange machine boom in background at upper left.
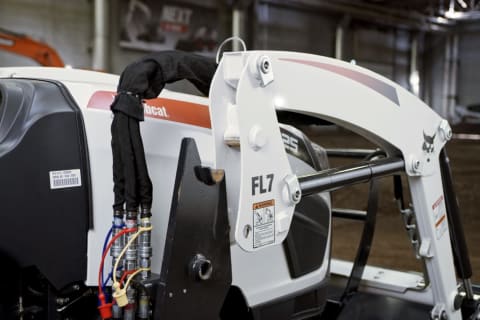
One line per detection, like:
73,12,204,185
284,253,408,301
0,28,65,67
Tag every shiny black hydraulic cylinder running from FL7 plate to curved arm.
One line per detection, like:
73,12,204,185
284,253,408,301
298,158,405,196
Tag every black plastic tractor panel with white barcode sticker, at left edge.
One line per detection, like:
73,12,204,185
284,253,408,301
0,78,91,289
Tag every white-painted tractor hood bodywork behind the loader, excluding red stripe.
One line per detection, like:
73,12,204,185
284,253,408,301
0,67,330,306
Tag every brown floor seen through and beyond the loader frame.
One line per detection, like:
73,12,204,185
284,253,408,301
304,127,480,284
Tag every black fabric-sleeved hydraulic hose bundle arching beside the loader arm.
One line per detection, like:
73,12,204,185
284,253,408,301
110,51,217,212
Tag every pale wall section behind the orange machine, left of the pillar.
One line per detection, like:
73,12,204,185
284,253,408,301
0,0,93,68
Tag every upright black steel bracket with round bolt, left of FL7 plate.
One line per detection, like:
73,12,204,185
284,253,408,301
152,138,232,320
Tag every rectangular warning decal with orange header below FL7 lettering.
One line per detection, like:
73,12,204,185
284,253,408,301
252,199,275,248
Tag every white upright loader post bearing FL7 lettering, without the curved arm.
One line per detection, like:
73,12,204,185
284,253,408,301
210,53,295,251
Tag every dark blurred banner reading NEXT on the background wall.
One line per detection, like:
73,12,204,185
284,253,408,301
120,0,219,56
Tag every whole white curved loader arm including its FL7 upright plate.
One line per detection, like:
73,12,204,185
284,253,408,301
210,51,461,320
